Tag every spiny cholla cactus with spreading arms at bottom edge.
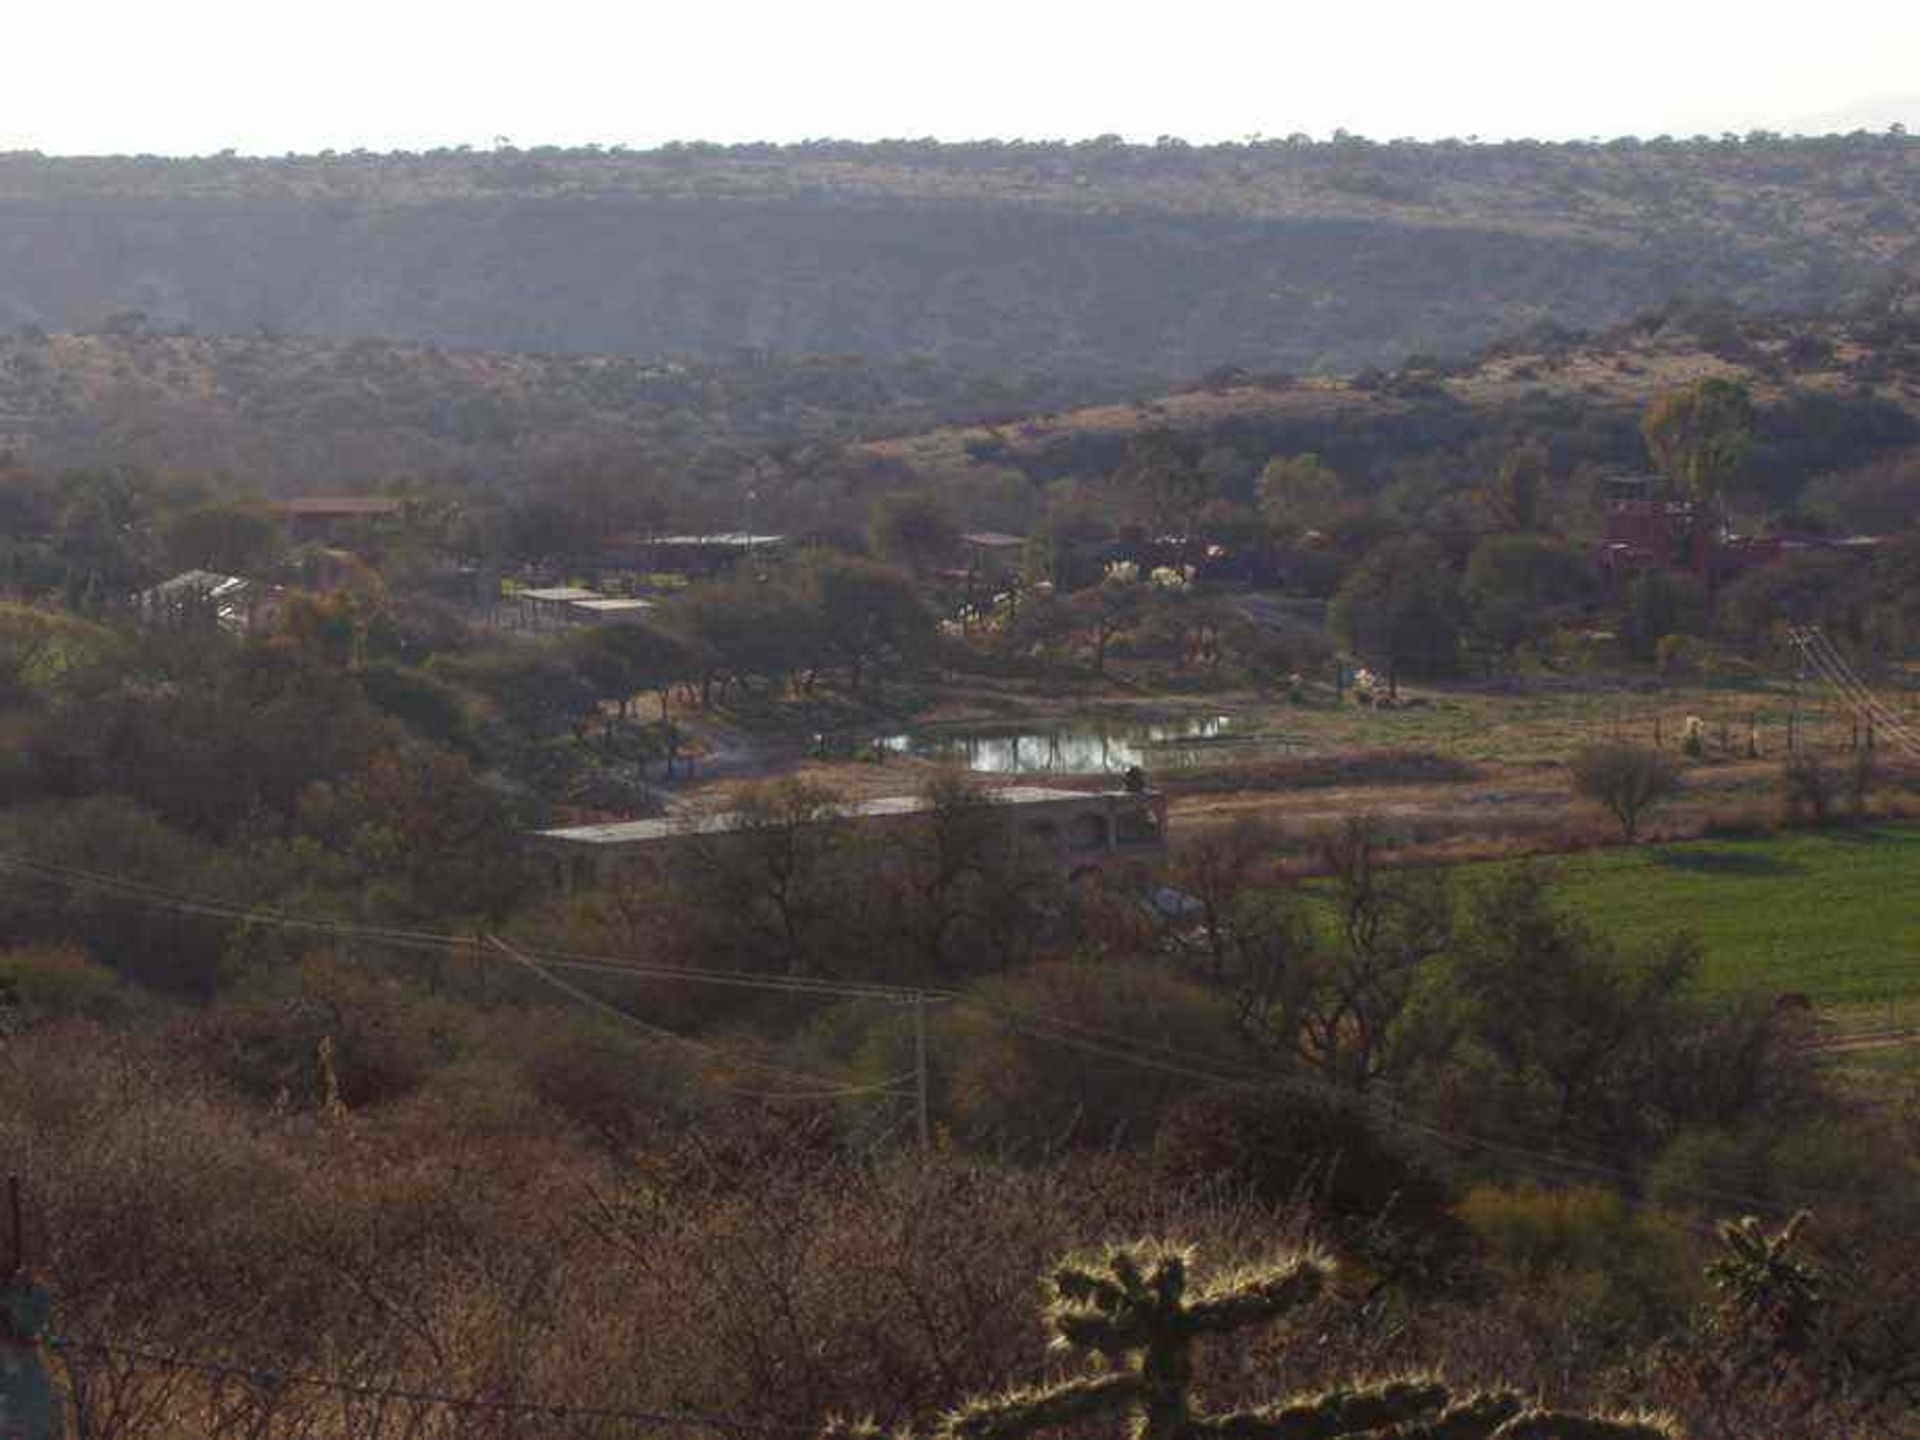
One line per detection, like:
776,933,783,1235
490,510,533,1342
828,1244,1674,1440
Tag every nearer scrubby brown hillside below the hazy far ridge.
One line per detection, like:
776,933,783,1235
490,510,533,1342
0,307,1920,532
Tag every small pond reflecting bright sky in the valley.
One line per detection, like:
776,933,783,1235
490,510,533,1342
879,714,1236,776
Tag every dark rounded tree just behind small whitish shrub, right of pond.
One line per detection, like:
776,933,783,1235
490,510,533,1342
1327,538,1461,682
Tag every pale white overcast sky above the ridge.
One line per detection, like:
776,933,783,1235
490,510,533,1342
0,0,1920,156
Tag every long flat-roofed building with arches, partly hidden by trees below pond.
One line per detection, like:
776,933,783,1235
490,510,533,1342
526,785,1167,891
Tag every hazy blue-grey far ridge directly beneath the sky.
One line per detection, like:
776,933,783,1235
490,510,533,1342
0,134,1920,374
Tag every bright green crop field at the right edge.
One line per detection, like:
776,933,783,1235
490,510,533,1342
1467,826,1920,1025
